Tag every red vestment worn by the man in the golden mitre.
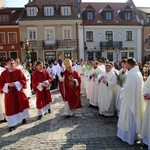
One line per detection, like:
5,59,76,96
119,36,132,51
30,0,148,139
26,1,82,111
59,70,82,110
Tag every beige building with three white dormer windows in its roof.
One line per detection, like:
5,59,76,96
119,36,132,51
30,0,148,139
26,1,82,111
19,0,82,61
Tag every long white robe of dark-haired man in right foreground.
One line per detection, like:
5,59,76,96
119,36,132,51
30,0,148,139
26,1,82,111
117,66,144,145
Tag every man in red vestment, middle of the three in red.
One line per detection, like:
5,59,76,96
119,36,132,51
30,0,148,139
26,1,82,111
32,61,52,120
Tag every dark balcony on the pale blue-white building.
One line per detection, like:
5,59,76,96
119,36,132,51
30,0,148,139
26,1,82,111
100,41,122,49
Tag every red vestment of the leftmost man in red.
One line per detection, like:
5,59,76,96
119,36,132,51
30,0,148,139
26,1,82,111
0,69,29,116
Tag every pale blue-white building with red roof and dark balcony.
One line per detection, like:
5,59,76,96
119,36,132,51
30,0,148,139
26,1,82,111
79,0,143,61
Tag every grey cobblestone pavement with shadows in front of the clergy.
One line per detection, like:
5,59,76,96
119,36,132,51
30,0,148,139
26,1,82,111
0,90,148,150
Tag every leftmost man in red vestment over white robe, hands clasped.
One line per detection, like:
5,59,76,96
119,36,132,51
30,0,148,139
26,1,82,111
0,58,29,132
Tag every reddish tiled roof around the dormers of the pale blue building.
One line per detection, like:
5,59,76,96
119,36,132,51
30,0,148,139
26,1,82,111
81,2,141,25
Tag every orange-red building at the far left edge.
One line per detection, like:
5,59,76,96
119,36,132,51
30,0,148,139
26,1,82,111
0,8,23,65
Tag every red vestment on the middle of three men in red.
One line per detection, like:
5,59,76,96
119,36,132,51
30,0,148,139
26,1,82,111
32,69,52,109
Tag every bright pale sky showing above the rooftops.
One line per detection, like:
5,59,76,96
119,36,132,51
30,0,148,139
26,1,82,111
4,0,150,7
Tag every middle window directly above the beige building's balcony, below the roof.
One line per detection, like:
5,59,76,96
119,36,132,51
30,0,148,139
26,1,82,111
45,27,55,40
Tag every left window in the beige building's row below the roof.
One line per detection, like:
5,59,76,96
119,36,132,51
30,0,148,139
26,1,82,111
27,27,37,41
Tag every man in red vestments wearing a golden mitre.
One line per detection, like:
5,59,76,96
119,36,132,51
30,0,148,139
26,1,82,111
59,59,82,117
